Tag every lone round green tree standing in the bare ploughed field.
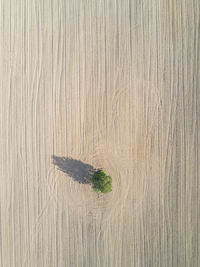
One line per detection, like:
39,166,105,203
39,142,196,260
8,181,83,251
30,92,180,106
92,169,112,193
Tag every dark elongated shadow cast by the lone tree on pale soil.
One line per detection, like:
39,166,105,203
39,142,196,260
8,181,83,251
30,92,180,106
52,155,96,184
